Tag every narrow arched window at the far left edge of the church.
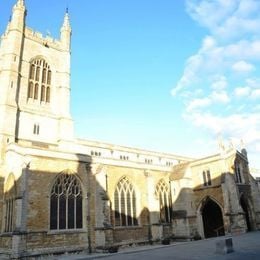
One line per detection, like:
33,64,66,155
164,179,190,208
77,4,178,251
4,174,16,232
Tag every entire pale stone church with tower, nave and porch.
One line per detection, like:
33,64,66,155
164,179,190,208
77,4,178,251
0,0,260,258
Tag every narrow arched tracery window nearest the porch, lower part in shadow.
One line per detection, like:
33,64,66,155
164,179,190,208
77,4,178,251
156,180,171,223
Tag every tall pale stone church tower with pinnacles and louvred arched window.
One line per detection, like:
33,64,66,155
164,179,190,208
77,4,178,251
0,0,73,160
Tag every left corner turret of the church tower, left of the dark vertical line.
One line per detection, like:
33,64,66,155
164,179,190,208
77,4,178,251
0,0,26,160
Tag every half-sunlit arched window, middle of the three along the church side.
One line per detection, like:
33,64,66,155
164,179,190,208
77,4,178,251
114,177,138,226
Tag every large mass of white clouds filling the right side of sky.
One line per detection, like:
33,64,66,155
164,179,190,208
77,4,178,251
172,0,260,167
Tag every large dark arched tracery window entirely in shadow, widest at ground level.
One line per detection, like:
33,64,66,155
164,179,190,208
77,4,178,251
50,174,83,230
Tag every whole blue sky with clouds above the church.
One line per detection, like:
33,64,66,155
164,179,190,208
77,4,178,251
0,0,260,168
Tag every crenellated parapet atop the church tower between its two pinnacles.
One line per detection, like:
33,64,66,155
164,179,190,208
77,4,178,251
25,27,61,49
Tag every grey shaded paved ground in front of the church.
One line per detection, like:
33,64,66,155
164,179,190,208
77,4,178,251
54,231,260,260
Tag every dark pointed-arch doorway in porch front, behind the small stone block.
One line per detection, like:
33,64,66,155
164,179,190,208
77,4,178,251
201,198,225,238
